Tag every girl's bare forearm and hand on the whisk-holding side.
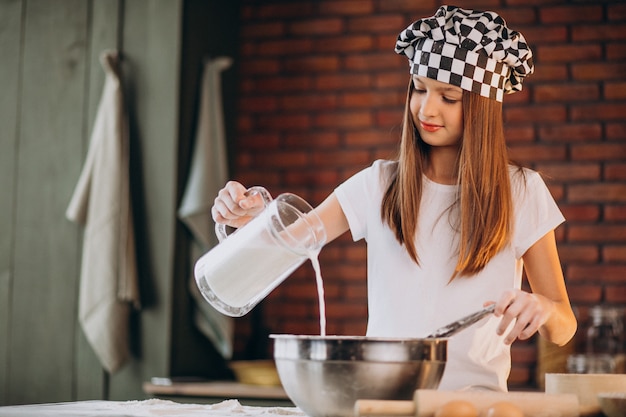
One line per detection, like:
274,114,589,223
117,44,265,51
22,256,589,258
495,231,577,346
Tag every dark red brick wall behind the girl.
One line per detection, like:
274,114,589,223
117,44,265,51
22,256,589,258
229,0,626,385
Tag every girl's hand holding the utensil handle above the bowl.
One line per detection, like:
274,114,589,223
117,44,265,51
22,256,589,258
488,289,555,345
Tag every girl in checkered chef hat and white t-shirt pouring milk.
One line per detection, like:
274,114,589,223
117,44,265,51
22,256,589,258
212,6,576,391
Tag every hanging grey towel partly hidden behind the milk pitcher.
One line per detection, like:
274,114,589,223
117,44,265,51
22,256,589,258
178,57,233,359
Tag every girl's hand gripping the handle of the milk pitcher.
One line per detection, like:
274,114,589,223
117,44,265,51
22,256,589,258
211,181,265,228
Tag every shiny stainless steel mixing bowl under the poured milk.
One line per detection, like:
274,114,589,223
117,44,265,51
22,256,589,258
270,335,447,417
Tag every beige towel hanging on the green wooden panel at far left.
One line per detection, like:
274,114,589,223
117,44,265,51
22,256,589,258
65,51,139,373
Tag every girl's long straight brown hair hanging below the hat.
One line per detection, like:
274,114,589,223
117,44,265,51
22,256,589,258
381,81,513,278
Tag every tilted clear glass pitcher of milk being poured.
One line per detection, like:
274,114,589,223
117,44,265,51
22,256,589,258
194,187,326,317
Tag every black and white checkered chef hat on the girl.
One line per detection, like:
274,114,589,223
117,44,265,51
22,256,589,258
395,6,534,101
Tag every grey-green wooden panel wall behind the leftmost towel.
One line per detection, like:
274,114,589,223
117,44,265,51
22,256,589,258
0,0,182,405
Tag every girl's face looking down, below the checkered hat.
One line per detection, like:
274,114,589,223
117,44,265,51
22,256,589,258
409,75,463,147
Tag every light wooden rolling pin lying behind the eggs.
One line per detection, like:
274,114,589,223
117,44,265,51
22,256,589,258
355,389,581,417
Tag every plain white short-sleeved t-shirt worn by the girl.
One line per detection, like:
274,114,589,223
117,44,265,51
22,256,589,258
335,160,565,391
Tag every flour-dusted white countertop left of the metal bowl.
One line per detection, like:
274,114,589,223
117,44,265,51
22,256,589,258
0,399,306,417
